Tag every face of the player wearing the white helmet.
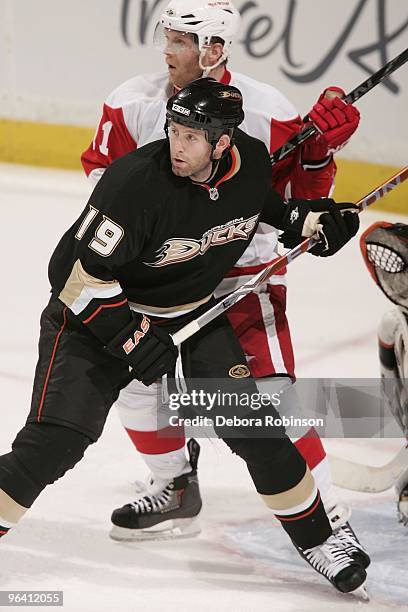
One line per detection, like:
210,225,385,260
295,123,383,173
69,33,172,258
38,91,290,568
164,30,202,89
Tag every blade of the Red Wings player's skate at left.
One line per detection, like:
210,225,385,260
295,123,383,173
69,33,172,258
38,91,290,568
109,518,201,542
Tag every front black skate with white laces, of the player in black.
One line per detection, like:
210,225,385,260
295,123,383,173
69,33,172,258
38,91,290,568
295,534,368,599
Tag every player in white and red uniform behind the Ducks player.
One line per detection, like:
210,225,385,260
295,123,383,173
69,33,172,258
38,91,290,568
82,0,368,565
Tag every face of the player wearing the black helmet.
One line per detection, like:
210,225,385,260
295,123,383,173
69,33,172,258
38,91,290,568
169,121,212,181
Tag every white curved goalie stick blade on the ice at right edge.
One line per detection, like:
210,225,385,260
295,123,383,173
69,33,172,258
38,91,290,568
329,446,408,493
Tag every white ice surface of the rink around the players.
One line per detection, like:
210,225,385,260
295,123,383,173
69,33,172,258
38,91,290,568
0,165,408,612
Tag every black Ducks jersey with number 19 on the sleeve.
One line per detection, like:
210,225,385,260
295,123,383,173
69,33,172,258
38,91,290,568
49,130,284,339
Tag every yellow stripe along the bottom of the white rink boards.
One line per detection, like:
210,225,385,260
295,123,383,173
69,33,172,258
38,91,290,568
0,119,408,215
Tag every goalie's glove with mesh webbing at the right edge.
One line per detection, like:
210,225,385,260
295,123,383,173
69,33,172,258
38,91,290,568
360,221,408,314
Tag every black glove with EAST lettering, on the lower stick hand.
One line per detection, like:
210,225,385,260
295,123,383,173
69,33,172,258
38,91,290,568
107,313,178,387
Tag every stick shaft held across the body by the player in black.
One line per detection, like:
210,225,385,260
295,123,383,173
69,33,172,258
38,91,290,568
172,166,408,345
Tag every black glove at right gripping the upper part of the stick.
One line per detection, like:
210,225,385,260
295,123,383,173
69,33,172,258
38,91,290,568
279,198,360,257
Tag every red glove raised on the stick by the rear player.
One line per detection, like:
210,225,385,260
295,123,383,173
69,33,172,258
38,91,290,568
302,87,360,161
